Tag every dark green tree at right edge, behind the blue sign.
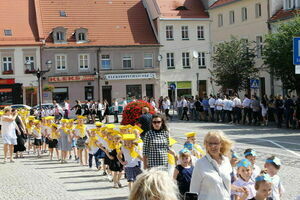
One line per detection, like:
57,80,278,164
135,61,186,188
263,16,300,95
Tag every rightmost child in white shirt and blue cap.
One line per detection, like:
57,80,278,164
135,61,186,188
265,156,284,200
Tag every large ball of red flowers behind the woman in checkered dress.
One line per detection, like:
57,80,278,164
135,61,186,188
121,100,155,125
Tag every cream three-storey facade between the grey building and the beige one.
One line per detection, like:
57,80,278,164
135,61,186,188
159,19,212,96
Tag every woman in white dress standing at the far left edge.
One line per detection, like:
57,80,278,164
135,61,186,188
1,106,17,163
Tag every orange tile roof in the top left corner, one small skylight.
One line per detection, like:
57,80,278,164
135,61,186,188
0,0,40,46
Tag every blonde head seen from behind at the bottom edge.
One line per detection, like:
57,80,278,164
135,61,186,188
128,168,179,200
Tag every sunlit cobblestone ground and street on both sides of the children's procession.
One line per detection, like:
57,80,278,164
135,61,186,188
0,118,300,200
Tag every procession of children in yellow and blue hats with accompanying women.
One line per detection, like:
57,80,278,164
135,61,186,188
0,103,290,200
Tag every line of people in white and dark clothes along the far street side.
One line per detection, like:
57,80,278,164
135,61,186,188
158,94,300,129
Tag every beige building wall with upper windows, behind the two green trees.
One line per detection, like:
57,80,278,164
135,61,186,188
209,0,280,95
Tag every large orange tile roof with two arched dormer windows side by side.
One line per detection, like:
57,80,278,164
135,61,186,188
35,0,158,46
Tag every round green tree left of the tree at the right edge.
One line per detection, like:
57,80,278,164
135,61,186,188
212,38,259,92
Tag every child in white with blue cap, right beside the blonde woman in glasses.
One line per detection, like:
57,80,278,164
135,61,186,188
232,159,256,200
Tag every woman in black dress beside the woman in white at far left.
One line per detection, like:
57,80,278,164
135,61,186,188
12,109,26,158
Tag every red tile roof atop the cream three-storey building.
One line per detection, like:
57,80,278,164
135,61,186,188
156,0,208,18
